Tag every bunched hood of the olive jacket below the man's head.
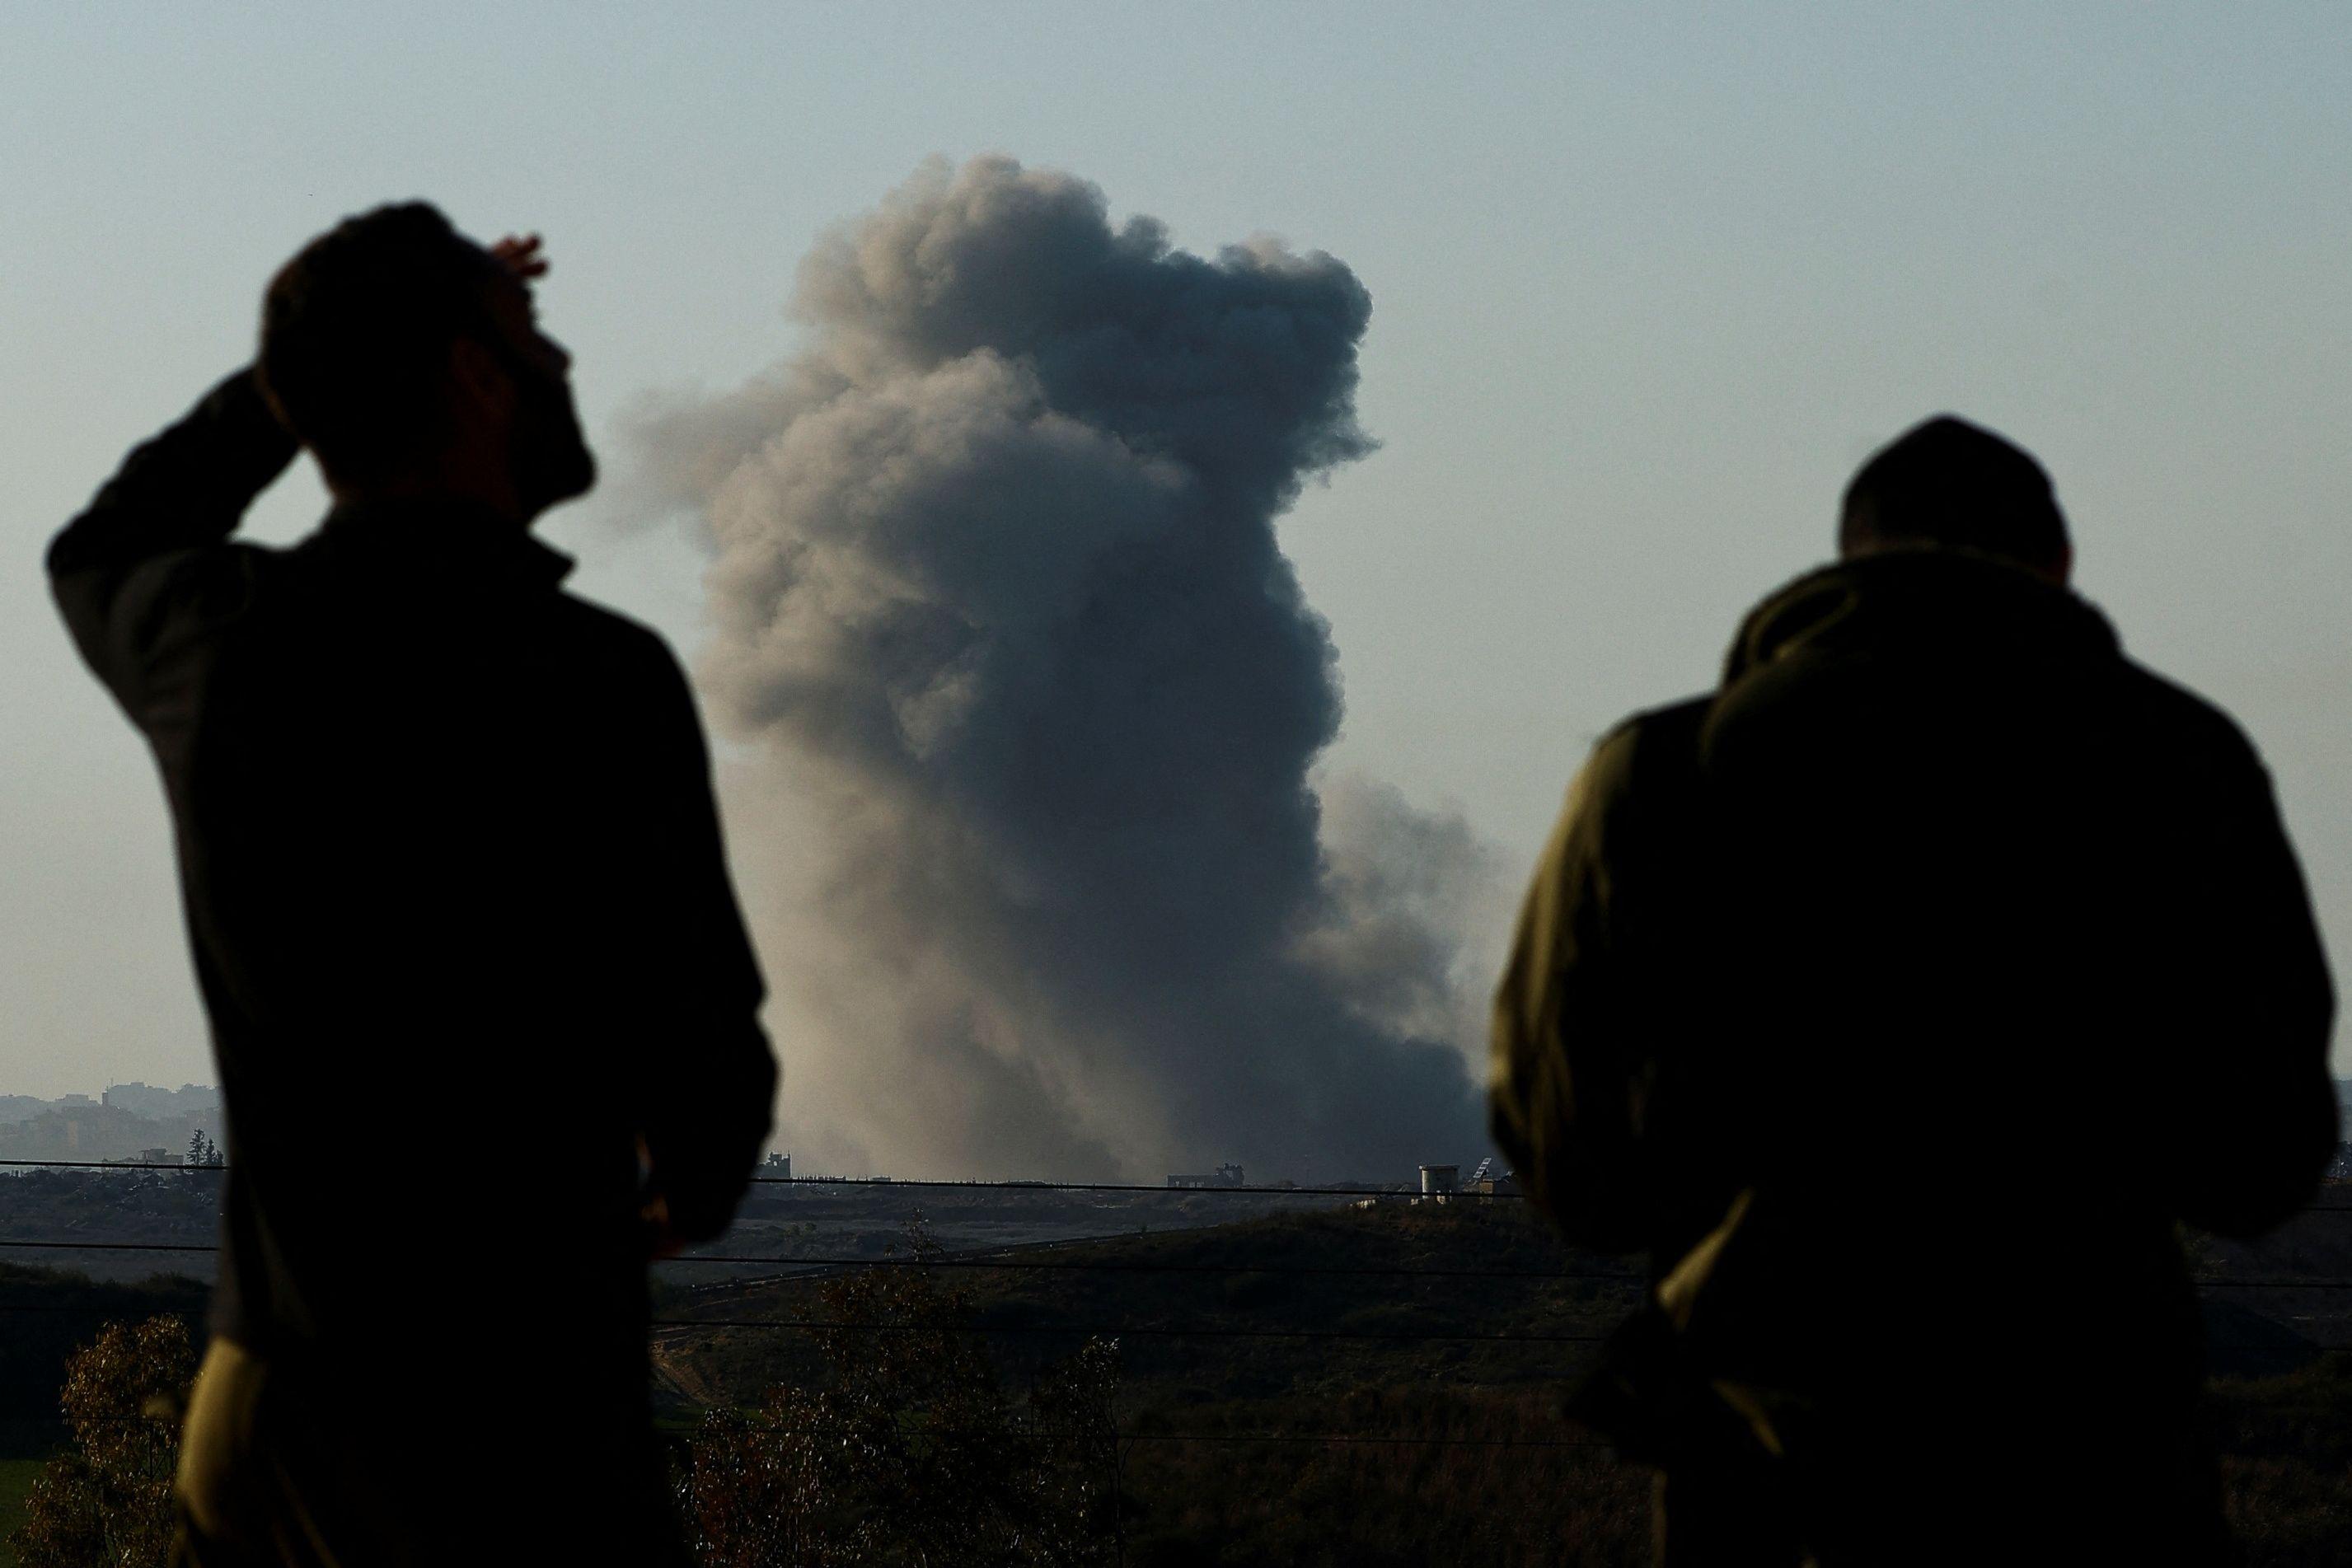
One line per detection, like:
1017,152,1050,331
1724,550,2121,686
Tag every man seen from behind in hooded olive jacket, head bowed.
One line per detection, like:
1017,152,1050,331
1493,419,2336,1568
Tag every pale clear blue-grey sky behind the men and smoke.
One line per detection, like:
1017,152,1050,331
0,0,2352,1098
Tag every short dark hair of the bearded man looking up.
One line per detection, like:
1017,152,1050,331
256,202,499,482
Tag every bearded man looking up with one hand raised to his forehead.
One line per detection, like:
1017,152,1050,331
49,204,774,1568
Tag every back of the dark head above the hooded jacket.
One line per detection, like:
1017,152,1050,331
1837,414,2070,567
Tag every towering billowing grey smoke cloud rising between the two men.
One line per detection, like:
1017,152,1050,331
642,157,1484,1180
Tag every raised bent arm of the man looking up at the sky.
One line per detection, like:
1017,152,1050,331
49,369,297,717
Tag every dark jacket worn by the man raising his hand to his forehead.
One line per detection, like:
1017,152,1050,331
49,374,776,1542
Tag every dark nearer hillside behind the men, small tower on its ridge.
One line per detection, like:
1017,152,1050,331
656,1190,2352,1566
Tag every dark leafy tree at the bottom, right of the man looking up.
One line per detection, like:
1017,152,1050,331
677,1220,1120,1568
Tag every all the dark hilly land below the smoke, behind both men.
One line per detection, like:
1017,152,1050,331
0,1173,2352,1568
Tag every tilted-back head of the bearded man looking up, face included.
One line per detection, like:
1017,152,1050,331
256,202,595,522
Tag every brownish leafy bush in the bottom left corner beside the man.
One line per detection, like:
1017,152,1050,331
7,1317,195,1568
